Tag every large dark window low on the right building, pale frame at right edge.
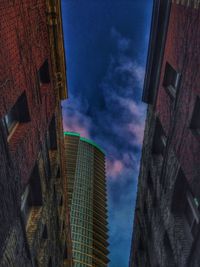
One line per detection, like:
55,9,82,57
172,170,200,238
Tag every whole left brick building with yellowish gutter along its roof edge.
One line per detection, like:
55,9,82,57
0,0,72,267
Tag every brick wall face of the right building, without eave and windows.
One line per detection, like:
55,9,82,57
130,1,200,267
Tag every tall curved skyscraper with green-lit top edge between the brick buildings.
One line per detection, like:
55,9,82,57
64,132,109,267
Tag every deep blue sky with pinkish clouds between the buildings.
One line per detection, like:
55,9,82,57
62,0,152,267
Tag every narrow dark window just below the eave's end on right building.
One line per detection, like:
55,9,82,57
152,118,167,155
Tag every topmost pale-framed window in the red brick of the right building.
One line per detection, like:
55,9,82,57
163,62,181,97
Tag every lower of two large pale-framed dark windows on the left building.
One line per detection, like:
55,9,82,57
21,165,42,225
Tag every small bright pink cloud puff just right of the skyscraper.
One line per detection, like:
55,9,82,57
106,160,124,180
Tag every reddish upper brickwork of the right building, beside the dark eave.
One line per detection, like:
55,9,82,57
156,4,200,191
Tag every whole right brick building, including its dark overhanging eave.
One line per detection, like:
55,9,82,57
129,0,200,267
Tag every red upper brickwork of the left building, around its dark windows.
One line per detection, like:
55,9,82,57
0,0,55,186
